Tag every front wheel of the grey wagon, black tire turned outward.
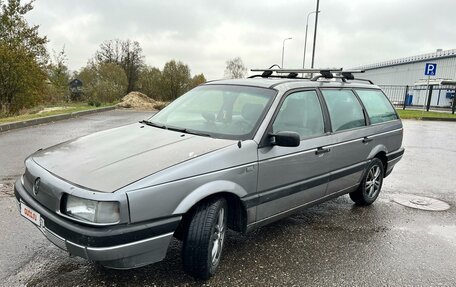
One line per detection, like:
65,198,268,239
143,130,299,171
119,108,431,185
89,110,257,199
182,198,228,280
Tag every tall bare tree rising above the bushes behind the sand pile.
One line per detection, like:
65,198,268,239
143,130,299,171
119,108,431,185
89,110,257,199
94,39,144,92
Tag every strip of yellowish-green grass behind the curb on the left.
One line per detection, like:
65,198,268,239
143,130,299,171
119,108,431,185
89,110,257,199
0,103,107,124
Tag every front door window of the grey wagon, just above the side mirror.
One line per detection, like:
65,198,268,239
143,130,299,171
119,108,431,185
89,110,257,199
272,91,325,140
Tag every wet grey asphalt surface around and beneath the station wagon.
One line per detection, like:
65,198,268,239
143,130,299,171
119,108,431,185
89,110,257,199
0,111,456,286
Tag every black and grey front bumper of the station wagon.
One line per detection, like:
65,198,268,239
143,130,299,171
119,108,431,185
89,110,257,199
14,180,181,269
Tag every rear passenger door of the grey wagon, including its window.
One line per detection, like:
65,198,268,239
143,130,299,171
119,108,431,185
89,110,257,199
321,89,371,194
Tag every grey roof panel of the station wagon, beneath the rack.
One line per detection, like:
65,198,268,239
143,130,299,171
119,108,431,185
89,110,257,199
205,77,380,89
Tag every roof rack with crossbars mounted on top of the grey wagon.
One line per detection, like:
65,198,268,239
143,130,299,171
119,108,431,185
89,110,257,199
249,68,374,85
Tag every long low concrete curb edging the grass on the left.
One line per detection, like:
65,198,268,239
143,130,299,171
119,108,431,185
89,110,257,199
0,106,116,133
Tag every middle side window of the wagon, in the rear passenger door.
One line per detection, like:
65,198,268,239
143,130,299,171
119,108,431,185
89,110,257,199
322,90,366,132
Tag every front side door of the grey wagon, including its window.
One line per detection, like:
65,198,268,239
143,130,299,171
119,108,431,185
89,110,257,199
257,90,330,220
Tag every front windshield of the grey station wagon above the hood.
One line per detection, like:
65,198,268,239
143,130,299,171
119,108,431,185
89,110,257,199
148,85,276,140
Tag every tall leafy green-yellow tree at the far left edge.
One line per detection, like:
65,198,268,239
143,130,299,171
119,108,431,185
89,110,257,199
0,0,48,115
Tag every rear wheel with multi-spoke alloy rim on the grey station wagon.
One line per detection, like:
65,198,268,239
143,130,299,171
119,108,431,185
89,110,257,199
350,158,384,206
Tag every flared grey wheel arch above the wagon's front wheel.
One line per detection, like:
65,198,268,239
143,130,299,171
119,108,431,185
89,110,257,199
173,180,247,214
